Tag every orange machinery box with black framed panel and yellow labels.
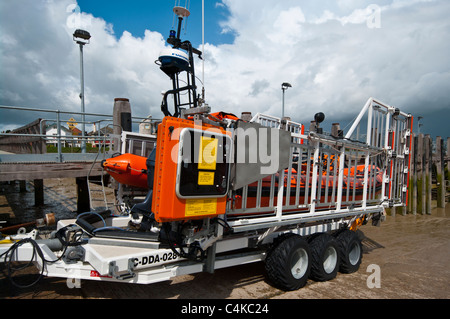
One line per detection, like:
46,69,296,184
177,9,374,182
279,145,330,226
152,117,232,222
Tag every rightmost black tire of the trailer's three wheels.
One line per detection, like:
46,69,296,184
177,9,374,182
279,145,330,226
336,229,363,274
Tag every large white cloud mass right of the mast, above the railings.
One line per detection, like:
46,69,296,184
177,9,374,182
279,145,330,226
203,0,450,123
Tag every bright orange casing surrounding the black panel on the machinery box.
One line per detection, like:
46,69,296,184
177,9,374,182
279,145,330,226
152,117,230,222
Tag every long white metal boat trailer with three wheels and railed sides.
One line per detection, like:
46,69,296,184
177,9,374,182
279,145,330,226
0,98,412,290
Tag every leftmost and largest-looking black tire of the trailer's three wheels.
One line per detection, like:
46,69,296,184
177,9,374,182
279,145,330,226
265,235,311,291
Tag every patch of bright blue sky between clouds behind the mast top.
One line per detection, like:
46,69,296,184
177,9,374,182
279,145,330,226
78,0,234,47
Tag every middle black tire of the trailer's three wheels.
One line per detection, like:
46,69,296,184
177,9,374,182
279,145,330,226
309,233,340,281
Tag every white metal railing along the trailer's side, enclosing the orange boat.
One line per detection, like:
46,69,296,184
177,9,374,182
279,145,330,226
227,98,412,227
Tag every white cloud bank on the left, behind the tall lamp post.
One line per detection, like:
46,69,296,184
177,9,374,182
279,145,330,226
0,0,169,129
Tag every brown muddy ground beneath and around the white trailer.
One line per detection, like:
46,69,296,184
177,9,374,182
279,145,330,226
0,179,450,299
